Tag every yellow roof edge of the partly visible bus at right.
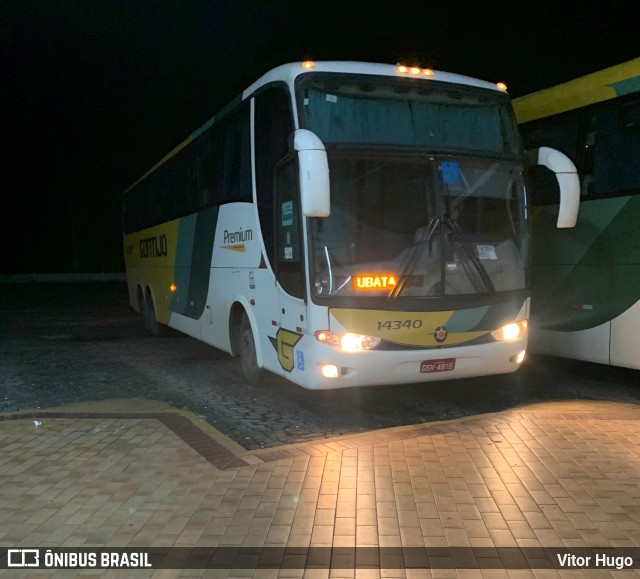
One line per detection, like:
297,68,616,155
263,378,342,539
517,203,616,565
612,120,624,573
513,58,640,123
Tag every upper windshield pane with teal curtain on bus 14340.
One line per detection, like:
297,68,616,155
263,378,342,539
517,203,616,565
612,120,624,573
301,75,518,155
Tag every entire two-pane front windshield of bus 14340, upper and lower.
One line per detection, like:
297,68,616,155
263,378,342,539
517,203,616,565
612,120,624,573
298,74,528,300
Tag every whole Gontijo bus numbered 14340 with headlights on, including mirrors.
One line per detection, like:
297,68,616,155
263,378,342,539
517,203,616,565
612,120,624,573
123,62,578,389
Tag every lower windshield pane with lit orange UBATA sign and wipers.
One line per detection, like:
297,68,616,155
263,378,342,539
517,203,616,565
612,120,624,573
308,149,528,300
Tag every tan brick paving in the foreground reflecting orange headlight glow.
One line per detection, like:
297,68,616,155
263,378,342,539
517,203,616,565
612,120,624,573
0,400,640,579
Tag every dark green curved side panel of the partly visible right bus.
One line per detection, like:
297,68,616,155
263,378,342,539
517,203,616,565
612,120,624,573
532,196,640,331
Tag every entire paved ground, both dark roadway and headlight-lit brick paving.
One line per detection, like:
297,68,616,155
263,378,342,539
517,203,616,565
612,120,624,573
0,284,640,579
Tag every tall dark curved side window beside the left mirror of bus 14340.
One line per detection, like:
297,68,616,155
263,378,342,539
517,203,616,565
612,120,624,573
254,87,293,264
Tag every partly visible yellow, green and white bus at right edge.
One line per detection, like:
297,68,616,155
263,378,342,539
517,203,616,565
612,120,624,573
514,58,640,368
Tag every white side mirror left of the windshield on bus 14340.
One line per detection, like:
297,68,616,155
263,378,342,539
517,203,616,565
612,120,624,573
293,129,331,217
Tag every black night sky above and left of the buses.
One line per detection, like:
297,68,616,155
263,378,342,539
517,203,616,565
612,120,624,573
0,0,640,273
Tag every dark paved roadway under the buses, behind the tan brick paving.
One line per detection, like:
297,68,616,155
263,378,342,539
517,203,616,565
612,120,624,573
0,283,640,449
